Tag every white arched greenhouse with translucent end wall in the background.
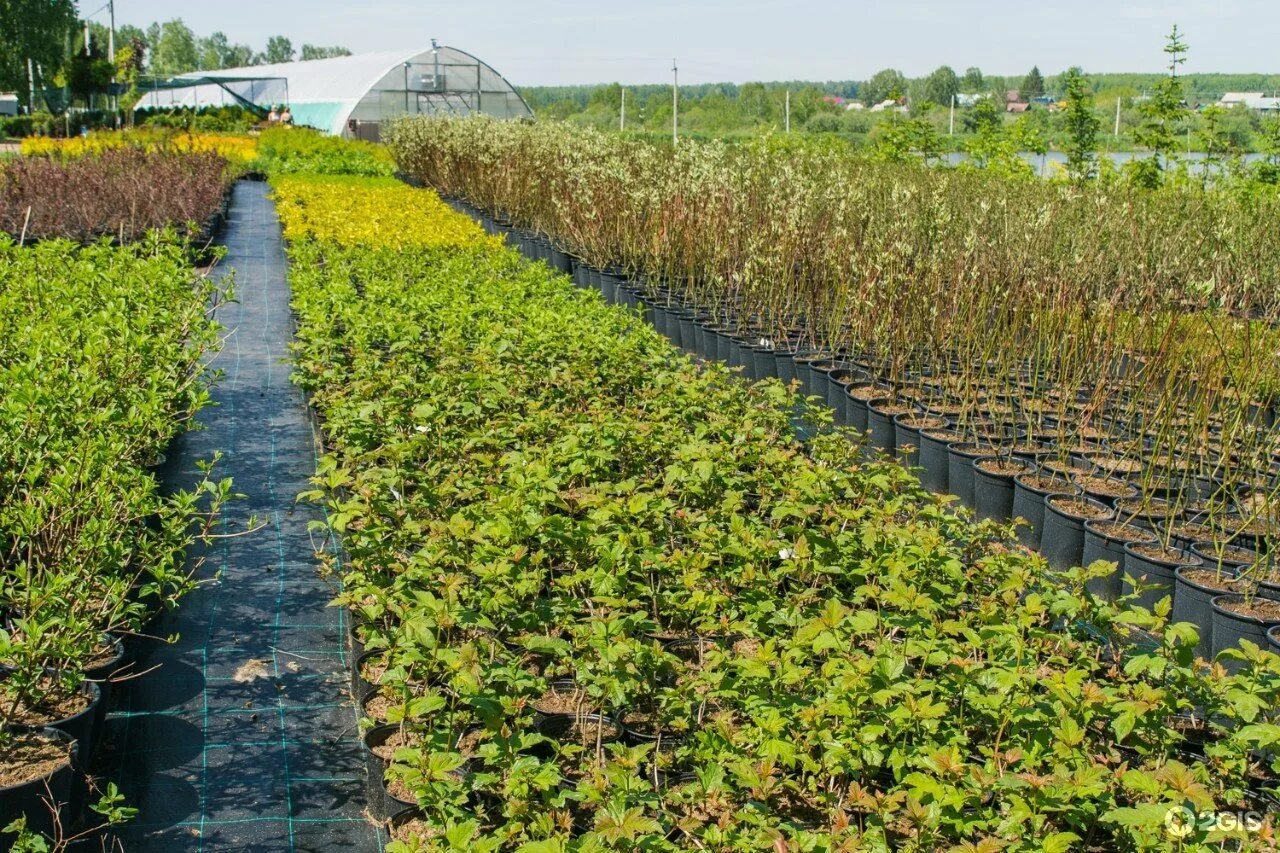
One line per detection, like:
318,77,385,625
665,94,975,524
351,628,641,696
137,46,532,140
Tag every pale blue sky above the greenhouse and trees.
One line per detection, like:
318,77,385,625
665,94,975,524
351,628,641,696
102,0,1280,86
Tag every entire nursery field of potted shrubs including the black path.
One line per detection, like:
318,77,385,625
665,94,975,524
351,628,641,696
0,119,1280,853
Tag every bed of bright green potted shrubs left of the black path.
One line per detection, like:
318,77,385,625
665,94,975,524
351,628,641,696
0,232,230,850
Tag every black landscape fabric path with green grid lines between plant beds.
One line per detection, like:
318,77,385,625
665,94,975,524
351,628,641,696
97,182,383,853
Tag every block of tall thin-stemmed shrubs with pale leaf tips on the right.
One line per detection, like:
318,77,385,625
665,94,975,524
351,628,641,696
389,119,1280,563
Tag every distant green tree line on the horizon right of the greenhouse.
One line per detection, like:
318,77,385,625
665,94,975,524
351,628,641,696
520,47,1280,160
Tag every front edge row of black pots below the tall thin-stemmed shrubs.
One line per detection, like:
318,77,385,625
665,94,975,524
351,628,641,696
481,233,1280,665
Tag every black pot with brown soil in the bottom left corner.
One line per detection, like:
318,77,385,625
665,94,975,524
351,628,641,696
0,729,78,849
